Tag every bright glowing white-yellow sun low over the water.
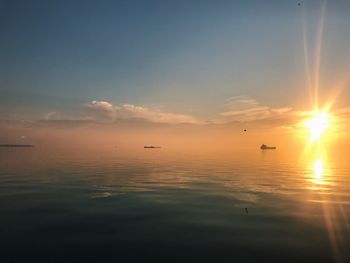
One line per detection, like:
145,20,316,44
305,112,330,141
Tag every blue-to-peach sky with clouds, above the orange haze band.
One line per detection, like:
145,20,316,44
0,0,350,129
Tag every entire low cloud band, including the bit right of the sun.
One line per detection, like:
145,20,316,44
39,96,350,131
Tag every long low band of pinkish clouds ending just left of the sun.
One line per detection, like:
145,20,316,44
44,96,293,127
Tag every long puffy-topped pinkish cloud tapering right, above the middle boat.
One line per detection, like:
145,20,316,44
86,100,199,124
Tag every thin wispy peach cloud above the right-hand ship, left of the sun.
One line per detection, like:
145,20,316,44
213,96,292,123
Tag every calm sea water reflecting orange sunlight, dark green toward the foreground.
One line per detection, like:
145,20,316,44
0,147,350,262
